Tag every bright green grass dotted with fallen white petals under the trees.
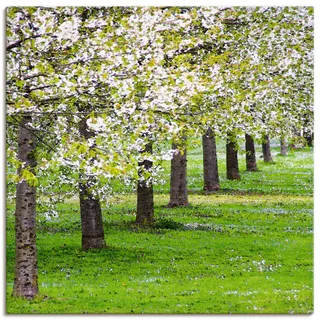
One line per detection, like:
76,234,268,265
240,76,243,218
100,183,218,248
6,139,313,314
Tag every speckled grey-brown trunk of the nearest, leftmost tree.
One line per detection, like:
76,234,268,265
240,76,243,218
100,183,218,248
13,116,38,299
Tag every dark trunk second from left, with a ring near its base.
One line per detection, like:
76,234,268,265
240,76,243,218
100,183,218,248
79,118,106,251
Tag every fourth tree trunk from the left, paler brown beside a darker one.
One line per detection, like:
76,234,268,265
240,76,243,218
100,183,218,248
168,143,189,208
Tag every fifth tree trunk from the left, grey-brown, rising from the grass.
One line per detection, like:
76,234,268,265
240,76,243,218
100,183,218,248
202,128,220,192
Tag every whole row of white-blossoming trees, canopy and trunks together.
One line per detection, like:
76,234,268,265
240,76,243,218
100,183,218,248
6,7,313,298
